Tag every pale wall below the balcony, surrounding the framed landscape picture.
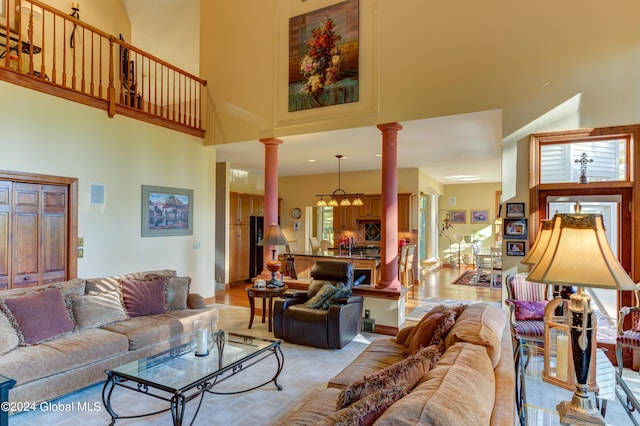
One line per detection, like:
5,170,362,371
0,82,215,297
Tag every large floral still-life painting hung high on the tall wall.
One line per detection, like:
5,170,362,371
289,0,359,112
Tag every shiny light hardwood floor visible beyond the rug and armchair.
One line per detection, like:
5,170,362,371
216,268,502,313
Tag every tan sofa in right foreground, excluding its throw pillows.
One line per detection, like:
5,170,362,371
283,303,515,426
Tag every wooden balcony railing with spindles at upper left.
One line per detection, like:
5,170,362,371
0,0,207,137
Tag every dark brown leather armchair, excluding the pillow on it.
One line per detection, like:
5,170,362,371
273,260,364,349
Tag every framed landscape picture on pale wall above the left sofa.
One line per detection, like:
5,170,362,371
142,185,193,237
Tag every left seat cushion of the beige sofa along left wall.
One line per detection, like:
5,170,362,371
0,328,128,385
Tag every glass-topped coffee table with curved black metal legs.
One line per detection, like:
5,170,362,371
102,332,284,425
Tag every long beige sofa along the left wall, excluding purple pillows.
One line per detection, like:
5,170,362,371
0,270,218,412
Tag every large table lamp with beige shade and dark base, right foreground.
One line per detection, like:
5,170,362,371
527,213,636,425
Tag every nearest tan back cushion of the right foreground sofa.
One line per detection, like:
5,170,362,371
376,343,496,426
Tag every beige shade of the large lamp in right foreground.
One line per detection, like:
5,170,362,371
527,214,636,290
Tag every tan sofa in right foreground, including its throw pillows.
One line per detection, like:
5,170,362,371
282,303,516,426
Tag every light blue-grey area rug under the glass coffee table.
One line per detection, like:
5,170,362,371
10,304,377,426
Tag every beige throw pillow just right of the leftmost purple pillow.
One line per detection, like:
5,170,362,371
71,294,129,330
